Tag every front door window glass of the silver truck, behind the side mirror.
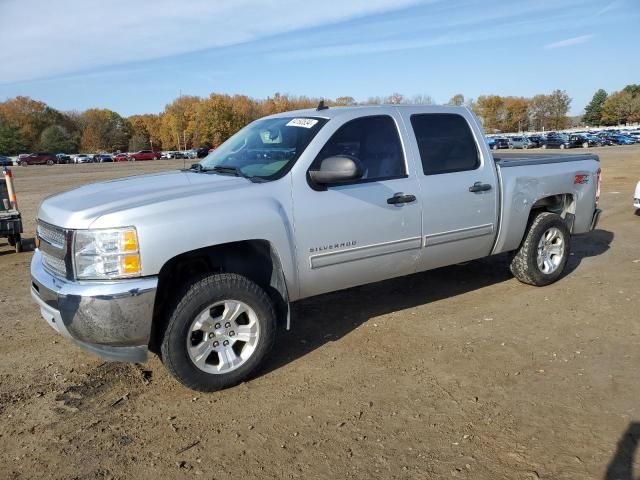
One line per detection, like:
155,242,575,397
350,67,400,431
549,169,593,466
314,116,406,181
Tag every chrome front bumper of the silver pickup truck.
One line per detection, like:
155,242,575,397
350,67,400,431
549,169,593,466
31,250,158,362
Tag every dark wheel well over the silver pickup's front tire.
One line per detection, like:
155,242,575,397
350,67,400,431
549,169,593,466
149,239,290,353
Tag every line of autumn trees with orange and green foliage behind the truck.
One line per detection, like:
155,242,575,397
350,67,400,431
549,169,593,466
0,85,640,155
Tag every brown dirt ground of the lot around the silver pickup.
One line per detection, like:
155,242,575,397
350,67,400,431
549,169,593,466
0,146,640,480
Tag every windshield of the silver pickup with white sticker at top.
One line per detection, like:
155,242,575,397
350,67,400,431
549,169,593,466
200,117,327,180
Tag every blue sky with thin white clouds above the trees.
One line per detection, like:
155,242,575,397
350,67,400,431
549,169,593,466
0,0,640,115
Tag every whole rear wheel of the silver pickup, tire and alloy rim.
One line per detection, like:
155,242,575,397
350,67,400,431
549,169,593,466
510,212,571,287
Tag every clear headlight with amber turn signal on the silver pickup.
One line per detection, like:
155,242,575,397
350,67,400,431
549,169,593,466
73,227,142,280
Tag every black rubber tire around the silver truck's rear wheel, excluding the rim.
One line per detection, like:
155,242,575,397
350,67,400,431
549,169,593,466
510,212,571,287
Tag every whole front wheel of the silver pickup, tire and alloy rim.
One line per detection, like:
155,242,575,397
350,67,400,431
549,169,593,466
160,274,276,392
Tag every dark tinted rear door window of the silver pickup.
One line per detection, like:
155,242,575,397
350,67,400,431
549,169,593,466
411,113,480,175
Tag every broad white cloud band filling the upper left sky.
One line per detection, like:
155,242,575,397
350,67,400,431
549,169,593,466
0,0,419,84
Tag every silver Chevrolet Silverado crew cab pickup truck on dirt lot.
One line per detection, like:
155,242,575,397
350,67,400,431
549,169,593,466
31,106,600,391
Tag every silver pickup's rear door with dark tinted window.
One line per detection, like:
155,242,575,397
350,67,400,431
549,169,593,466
402,109,499,270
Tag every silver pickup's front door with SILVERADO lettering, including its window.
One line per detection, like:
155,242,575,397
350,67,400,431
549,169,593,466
293,114,421,297
